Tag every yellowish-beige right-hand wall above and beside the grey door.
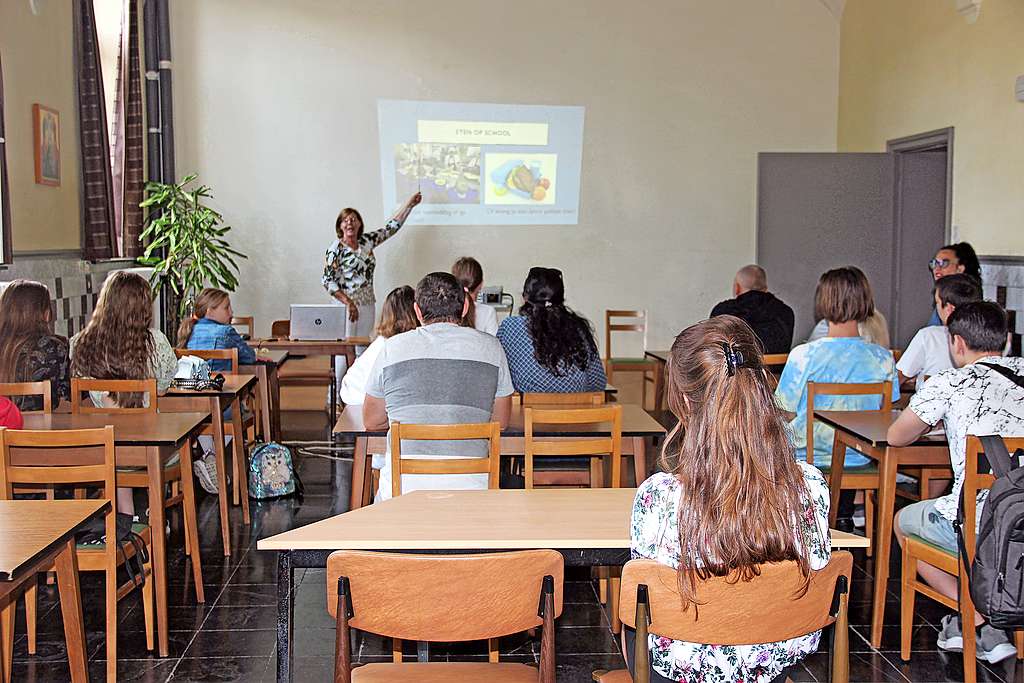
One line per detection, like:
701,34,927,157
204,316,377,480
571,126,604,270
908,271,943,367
839,0,1024,255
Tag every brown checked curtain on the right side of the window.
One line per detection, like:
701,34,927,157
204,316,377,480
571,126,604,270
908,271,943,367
112,0,145,258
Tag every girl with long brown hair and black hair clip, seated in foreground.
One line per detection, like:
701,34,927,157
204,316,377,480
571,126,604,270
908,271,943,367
626,315,831,683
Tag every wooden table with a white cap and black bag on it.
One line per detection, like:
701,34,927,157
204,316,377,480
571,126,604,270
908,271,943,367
157,375,259,557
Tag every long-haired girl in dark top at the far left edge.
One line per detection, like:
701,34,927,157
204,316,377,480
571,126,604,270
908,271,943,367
0,280,71,411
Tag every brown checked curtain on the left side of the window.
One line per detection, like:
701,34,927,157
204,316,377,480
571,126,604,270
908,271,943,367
75,0,117,261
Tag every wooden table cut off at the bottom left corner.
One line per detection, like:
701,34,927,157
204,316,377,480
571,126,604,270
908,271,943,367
0,500,111,683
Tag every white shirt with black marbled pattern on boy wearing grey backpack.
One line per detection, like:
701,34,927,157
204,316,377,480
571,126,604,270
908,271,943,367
909,355,1024,521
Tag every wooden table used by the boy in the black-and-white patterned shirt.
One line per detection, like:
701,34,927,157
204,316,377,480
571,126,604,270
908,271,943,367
814,411,949,648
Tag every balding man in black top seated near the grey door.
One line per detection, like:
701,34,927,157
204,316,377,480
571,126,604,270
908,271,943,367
711,264,794,353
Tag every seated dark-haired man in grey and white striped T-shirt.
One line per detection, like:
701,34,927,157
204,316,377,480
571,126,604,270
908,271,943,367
362,272,514,501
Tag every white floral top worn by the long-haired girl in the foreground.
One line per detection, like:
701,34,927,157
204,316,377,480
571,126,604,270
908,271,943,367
630,462,831,683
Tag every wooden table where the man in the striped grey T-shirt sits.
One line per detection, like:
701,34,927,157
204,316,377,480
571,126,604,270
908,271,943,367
333,402,666,510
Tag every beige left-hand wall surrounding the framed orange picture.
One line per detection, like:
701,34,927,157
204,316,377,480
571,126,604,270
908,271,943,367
0,0,81,252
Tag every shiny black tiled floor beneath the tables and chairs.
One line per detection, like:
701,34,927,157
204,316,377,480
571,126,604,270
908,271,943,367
6,414,1024,683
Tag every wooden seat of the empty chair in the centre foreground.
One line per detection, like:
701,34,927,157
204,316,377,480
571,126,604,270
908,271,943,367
352,661,538,683
